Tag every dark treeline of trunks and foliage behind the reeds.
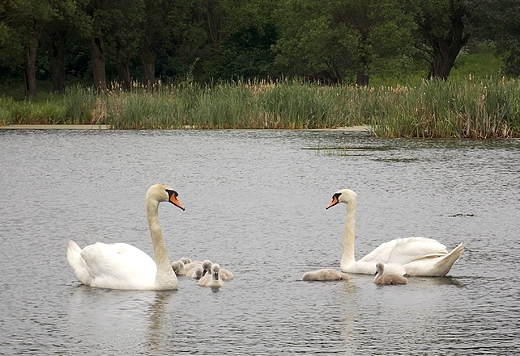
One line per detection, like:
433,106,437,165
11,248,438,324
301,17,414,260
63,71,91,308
0,0,520,95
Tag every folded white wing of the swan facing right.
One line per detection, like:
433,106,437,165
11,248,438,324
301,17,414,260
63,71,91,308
80,242,157,289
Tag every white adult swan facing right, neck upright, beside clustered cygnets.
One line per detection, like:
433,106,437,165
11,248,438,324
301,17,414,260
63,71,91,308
67,184,184,290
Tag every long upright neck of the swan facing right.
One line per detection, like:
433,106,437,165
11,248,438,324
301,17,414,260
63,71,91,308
146,199,175,281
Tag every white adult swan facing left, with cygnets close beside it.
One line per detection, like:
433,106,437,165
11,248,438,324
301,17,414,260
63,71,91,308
326,189,466,277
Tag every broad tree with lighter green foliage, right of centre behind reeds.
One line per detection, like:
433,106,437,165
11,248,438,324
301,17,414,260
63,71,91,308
275,0,413,86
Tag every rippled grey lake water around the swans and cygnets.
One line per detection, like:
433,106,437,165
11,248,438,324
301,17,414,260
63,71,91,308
0,130,520,355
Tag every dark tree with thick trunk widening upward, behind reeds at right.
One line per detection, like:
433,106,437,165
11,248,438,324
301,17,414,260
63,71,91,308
415,0,470,80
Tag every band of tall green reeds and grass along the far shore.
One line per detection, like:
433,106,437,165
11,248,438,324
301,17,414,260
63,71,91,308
0,77,520,138
